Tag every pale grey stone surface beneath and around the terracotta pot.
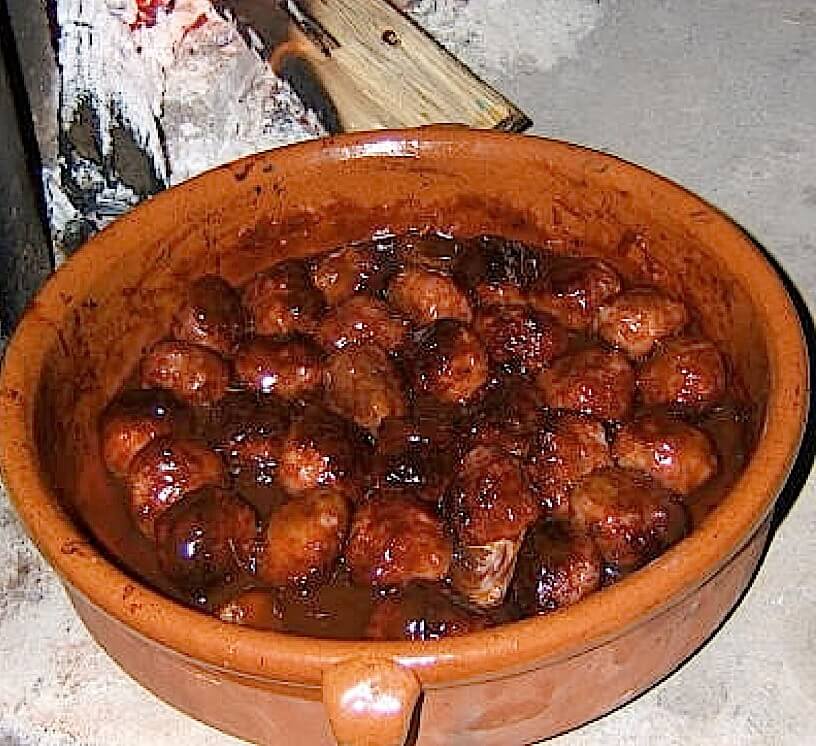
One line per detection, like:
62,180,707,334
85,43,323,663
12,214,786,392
0,0,816,746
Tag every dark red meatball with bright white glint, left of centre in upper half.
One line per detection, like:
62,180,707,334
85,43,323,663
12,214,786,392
235,335,323,399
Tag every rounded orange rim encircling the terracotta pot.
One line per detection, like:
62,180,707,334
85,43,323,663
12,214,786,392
0,127,809,687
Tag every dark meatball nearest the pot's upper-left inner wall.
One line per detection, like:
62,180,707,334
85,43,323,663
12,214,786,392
173,275,246,357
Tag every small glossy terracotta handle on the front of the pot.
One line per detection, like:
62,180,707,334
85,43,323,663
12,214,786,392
323,658,421,746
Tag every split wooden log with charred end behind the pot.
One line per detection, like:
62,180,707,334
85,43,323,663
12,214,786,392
219,0,532,132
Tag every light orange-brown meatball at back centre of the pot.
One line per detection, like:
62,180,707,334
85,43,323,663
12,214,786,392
388,266,472,326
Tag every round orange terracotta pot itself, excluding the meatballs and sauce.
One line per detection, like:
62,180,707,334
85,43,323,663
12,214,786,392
0,128,808,746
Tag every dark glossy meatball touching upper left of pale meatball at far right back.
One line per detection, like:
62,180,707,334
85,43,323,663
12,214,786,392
530,257,621,329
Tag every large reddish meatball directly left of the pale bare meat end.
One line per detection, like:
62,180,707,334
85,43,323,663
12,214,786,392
346,497,451,586
